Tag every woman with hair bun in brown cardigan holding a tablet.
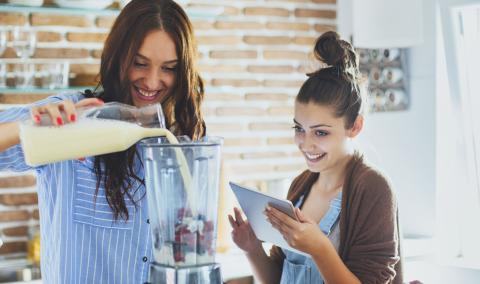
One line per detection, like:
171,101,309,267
229,32,402,284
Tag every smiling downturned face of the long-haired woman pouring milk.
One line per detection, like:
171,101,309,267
128,30,178,107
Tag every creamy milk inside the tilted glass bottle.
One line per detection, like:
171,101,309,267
20,118,178,166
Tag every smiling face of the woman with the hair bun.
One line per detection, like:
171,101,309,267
294,102,352,172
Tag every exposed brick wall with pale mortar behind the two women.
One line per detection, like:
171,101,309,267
0,0,336,254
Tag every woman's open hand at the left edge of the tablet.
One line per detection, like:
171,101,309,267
228,207,262,253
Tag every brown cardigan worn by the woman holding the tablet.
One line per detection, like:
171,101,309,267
270,153,403,284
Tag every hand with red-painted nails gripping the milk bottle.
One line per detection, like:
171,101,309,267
30,98,103,126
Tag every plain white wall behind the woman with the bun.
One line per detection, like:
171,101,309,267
338,0,436,236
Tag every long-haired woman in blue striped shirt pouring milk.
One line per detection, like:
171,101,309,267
0,0,205,284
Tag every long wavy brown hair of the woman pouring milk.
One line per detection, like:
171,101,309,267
88,0,205,220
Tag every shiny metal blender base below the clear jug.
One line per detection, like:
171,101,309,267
149,263,223,284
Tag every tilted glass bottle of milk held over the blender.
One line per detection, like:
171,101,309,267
20,103,178,166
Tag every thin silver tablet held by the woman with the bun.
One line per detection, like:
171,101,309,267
230,182,308,256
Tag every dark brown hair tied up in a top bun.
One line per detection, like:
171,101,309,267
296,31,365,129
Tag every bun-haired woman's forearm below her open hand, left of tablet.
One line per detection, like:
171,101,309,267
247,248,282,284
